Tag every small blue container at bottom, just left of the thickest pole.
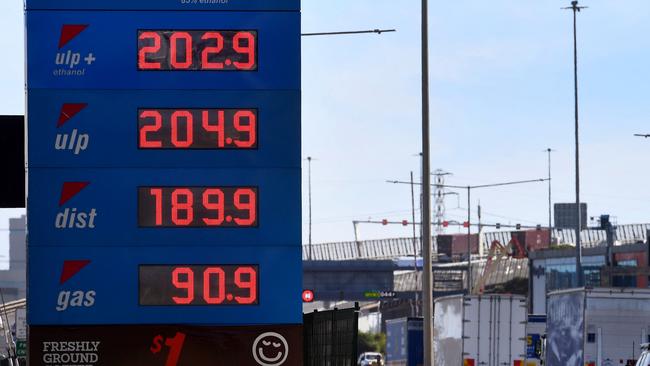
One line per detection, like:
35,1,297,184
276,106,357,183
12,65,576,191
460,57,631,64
386,318,424,366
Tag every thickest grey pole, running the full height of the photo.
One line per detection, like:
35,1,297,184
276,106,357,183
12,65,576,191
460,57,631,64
422,0,434,366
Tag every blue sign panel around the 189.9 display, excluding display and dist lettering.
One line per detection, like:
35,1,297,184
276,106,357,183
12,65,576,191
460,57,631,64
27,168,301,247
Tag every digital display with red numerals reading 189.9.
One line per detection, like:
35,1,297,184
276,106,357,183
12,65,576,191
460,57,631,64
138,187,258,227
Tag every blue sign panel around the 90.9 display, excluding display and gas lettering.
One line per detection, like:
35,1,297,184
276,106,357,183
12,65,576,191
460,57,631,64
27,244,302,325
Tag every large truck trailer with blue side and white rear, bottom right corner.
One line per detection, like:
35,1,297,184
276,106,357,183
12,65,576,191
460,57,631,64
546,288,650,366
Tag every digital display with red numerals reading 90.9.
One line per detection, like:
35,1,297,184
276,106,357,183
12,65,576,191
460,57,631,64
139,265,259,306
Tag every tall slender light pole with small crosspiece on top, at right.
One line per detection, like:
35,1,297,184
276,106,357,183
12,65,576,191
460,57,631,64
564,0,586,287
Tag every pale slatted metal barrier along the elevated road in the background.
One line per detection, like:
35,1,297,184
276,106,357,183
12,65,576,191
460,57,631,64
302,224,650,260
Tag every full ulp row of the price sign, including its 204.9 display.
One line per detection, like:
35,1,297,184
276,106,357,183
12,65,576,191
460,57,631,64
28,89,300,168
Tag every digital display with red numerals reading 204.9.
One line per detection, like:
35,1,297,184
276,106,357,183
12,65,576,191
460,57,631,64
138,108,257,149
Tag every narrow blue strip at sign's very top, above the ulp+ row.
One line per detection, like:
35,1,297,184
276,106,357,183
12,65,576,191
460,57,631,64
26,0,300,11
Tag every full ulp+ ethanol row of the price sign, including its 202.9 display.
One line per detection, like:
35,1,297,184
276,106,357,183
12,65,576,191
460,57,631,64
26,11,300,90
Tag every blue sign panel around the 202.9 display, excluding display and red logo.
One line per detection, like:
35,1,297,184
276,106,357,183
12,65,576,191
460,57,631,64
26,11,300,90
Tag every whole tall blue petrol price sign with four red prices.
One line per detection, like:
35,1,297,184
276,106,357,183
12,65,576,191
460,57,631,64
26,0,302,366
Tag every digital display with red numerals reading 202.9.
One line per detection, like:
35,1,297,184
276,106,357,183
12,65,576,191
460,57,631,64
138,30,257,71
